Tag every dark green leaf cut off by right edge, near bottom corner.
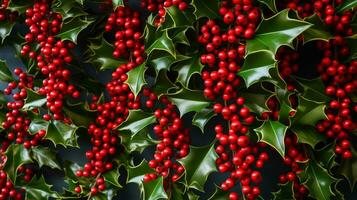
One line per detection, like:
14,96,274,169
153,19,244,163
338,149,357,191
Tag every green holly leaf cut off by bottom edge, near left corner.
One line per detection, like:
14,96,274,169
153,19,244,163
21,176,59,199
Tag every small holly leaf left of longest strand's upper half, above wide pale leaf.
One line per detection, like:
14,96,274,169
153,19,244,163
173,54,204,87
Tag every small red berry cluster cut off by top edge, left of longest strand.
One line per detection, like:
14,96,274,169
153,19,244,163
141,0,188,26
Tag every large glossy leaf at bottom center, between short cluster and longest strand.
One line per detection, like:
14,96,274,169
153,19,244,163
178,145,218,192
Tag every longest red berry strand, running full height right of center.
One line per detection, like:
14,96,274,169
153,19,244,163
198,0,269,200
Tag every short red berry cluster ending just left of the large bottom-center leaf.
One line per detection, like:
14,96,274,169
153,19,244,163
143,89,190,182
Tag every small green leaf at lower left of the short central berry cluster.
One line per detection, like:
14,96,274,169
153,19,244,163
127,160,155,186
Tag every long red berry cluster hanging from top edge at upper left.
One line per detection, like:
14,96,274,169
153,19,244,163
21,1,80,120
